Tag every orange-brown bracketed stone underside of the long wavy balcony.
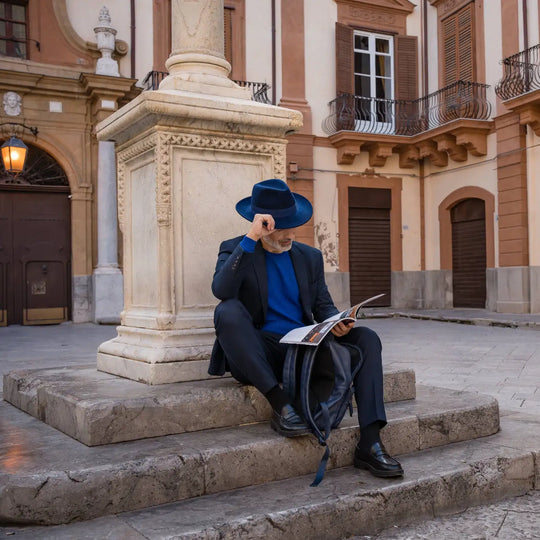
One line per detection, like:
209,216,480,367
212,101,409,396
328,119,494,169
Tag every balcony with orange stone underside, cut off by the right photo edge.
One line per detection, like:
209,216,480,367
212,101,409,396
495,45,540,136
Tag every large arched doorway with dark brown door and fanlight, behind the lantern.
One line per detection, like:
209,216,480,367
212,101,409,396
0,144,71,326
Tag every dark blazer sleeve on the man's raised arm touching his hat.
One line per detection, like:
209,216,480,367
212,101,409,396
212,237,252,300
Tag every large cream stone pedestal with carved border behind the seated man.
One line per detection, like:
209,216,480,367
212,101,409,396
97,98,301,384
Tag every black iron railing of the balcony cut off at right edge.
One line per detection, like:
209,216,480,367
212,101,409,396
495,45,540,99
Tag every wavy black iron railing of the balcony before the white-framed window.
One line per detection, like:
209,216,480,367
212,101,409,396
322,81,491,135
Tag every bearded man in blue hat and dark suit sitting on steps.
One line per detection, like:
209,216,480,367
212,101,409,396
208,179,403,477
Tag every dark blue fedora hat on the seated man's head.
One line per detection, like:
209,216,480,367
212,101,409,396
236,178,313,229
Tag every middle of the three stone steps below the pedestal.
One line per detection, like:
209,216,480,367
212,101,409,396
0,387,499,524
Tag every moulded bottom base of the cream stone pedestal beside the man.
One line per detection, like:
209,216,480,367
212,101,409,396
97,326,215,384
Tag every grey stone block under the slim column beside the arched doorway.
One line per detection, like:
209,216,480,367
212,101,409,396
92,266,124,324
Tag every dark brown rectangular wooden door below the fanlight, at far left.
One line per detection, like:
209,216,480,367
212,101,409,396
0,190,71,325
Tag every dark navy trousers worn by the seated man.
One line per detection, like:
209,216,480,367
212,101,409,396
214,299,386,428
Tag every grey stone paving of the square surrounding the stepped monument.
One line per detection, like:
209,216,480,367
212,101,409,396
0,313,540,540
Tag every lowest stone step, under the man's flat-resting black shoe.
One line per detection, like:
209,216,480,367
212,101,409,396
84,417,540,540
